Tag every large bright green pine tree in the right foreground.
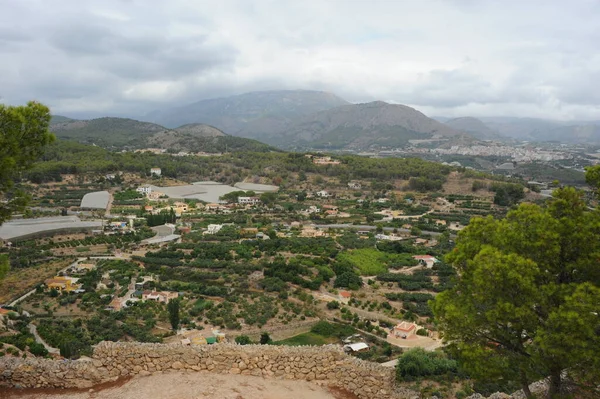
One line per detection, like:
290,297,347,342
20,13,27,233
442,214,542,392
431,188,600,398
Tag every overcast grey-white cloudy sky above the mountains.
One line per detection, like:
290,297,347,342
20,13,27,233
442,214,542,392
0,0,600,119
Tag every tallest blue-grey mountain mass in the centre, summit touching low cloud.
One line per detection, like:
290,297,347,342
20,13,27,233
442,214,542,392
143,90,474,150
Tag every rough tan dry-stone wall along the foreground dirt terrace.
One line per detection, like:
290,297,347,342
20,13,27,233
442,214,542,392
0,342,418,399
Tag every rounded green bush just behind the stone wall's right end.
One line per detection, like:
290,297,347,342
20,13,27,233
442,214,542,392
396,348,457,381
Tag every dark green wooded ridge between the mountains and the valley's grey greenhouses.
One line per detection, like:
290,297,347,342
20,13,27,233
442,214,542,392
26,140,452,187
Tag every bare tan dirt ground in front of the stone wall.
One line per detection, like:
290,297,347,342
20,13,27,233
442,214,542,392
0,372,356,399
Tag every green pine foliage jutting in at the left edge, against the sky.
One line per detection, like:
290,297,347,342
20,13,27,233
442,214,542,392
0,102,54,224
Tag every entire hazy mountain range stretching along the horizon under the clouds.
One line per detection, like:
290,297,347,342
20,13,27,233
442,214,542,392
52,90,600,151
